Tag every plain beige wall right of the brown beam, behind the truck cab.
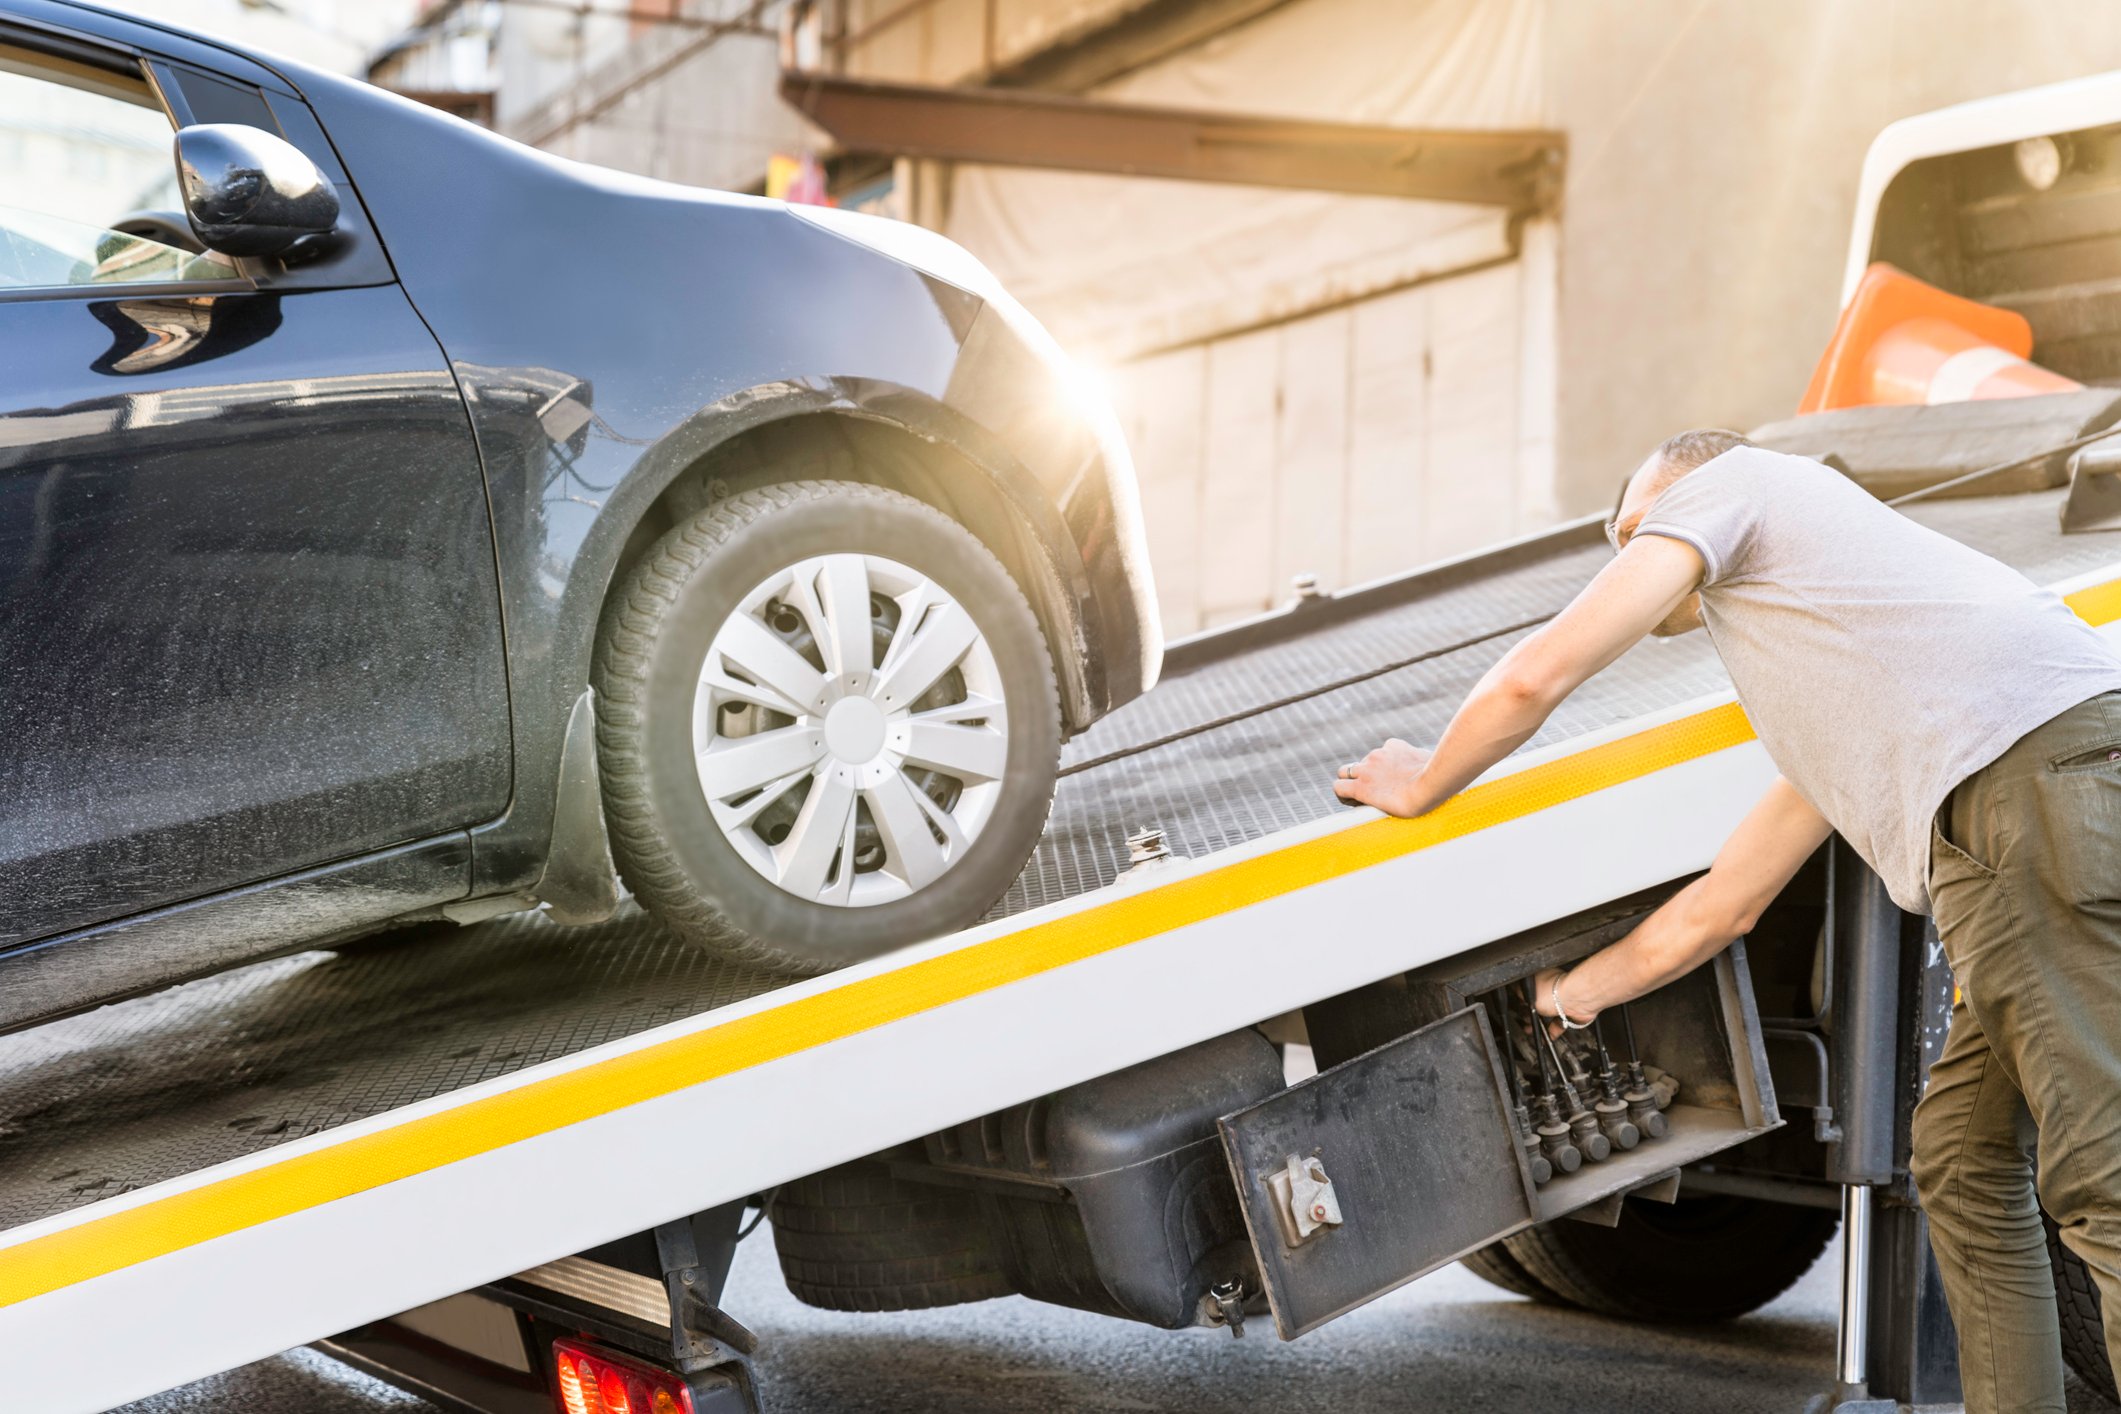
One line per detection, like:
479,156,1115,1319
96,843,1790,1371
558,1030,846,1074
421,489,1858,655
1546,0,2121,513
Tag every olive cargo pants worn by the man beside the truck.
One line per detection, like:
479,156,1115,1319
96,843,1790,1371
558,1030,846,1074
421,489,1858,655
1913,693,2121,1414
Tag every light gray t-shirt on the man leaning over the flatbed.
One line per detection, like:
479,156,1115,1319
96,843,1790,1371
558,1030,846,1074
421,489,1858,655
1635,447,2121,914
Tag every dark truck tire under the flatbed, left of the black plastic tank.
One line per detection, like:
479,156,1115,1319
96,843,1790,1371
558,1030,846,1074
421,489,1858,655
772,1160,1014,1310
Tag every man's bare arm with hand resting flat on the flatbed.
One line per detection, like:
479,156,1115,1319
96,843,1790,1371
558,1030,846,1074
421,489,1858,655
1334,534,1703,816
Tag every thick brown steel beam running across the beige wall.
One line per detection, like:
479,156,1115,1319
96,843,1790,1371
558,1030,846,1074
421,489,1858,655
781,70,1567,212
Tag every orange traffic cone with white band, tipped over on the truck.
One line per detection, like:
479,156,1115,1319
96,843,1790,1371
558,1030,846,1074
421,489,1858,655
1796,261,2083,413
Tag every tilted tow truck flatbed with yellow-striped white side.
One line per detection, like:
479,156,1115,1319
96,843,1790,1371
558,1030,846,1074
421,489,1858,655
0,492,2121,1410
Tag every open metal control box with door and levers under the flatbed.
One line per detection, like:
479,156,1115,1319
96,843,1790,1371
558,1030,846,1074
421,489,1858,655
1222,905,1782,1340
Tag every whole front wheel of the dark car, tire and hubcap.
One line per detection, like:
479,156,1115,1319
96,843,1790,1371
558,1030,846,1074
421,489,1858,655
596,481,1061,973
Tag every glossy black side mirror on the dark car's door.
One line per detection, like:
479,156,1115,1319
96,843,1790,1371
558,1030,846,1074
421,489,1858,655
176,123,339,257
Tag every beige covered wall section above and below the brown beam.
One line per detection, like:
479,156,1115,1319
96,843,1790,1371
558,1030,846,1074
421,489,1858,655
942,0,1557,636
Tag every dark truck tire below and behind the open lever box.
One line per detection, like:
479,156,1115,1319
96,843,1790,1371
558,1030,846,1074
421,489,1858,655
1504,1194,1841,1325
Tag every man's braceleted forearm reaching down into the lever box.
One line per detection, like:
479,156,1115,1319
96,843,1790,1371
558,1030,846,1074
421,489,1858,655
1536,778,1833,1022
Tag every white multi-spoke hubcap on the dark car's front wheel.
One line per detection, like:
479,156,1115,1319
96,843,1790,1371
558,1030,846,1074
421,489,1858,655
694,553,1010,905
